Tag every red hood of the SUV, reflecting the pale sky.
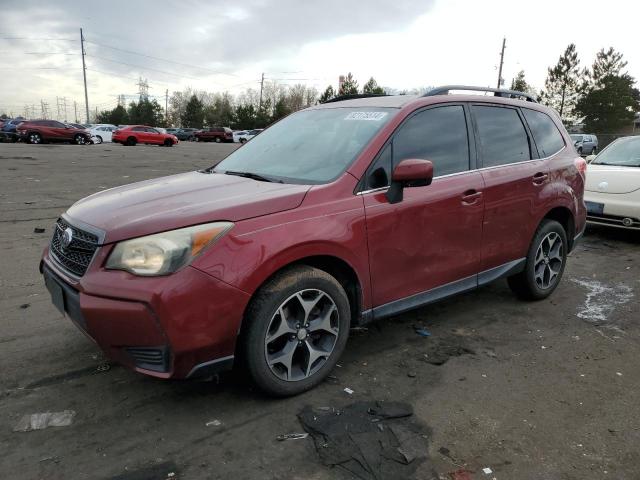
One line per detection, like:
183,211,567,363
66,172,310,243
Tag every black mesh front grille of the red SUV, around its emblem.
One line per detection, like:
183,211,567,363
49,218,99,277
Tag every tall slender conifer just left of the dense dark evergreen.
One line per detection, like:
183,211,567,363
540,43,583,122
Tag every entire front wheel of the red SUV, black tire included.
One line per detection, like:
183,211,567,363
240,265,351,396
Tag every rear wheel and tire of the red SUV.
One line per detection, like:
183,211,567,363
508,219,568,300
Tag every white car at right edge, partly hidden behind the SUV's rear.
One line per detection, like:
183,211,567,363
584,136,640,230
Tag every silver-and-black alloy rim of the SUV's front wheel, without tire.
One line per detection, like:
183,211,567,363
264,289,340,382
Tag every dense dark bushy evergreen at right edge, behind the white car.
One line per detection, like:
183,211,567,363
576,74,640,133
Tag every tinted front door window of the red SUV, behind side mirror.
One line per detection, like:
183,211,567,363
393,105,469,176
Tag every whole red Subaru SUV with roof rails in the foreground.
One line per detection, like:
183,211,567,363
40,87,586,395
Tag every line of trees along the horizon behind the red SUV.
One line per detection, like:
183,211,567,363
92,53,640,133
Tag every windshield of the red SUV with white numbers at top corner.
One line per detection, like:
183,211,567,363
214,107,396,184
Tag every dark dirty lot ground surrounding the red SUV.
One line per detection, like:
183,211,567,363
0,143,640,480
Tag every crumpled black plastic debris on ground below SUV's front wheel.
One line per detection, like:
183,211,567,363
298,401,428,480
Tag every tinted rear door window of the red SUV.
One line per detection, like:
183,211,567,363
473,105,531,167
